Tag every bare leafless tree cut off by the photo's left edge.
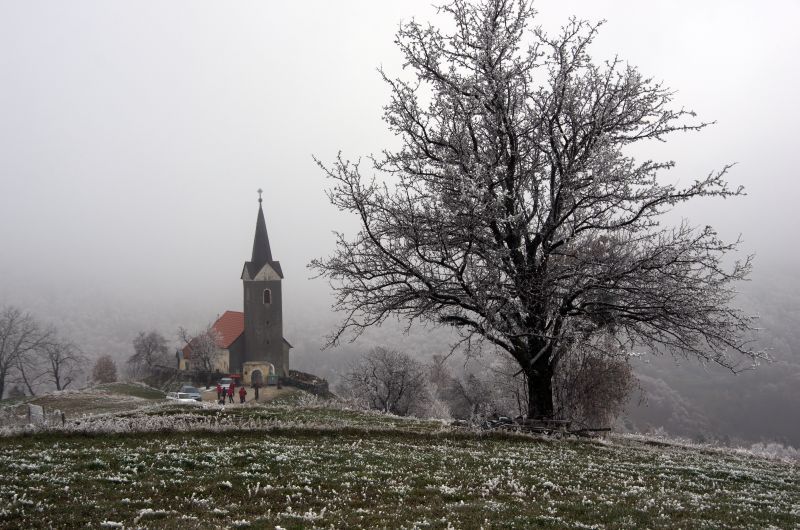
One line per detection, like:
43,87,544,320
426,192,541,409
0,306,51,398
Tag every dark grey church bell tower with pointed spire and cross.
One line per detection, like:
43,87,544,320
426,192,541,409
242,190,291,381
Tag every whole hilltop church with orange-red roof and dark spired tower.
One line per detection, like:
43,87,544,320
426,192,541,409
178,190,292,385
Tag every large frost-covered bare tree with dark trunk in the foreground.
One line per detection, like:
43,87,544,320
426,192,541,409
311,0,764,417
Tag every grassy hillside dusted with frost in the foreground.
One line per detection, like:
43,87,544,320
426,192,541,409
0,386,800,528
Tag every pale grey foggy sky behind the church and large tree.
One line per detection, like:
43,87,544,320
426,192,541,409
0,0,800,445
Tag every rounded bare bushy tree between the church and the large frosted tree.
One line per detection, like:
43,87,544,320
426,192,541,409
340,347,427,416
